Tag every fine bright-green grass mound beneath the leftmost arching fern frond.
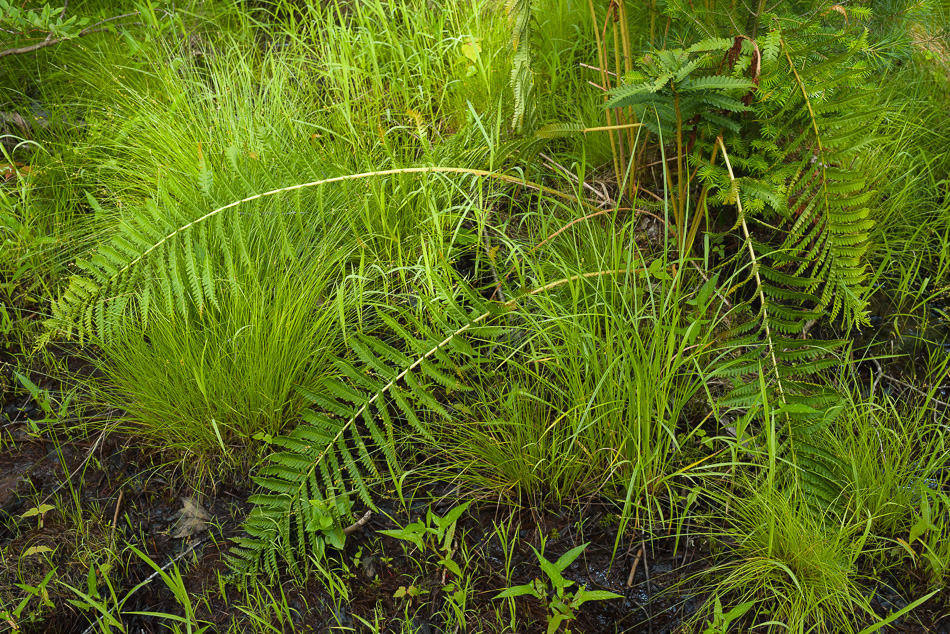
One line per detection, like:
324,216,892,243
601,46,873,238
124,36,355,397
96,260,339,476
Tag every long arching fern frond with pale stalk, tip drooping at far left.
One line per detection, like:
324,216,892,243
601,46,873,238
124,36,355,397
45,167,596,340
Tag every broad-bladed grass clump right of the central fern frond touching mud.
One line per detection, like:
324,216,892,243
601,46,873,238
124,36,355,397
439,239,728,506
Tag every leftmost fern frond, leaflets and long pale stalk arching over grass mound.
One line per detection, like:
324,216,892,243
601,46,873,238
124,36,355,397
48,160,556,343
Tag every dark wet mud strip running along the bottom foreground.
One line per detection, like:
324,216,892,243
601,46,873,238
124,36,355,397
0,412,950,634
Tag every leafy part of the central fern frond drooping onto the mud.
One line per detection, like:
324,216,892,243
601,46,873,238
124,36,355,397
229,289,498,576
